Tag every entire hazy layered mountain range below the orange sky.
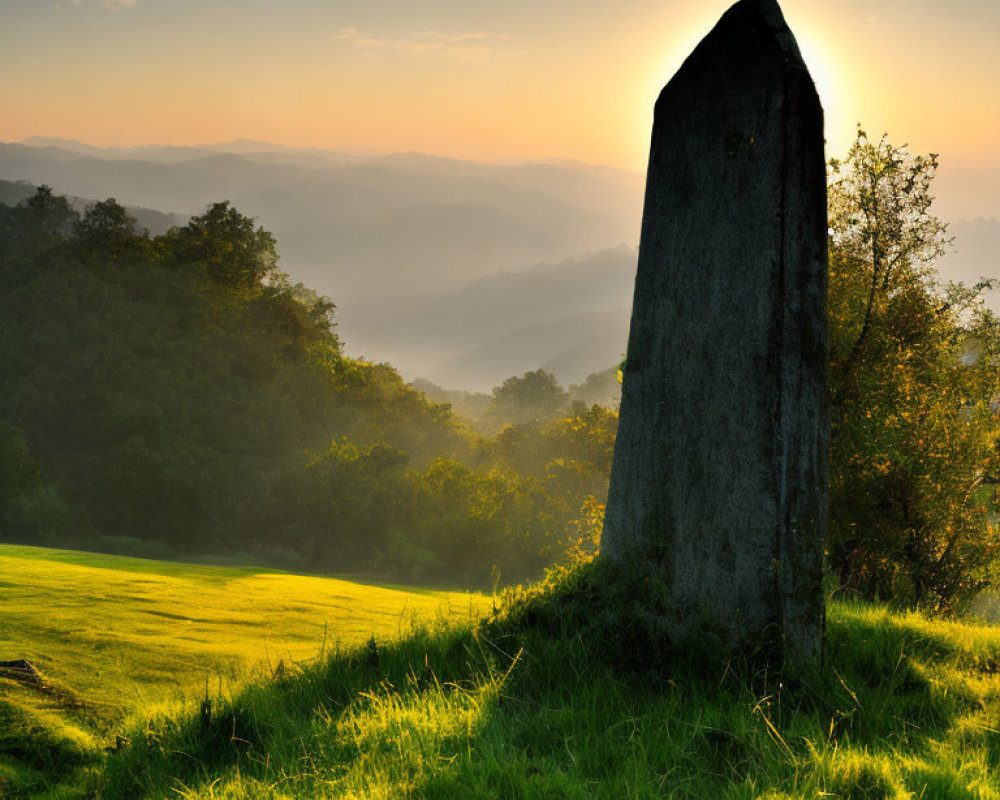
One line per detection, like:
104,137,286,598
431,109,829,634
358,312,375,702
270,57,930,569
0,137,1000,391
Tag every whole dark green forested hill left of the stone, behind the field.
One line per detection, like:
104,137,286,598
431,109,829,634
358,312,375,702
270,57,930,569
0,187,615,583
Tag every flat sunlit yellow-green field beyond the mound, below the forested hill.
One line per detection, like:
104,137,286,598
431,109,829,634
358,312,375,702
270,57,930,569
0,545,488,797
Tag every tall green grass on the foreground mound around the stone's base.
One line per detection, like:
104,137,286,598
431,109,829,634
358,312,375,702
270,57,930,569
9,548,1000,800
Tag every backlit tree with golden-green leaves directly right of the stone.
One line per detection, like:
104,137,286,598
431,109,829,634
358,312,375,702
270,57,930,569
828,129,1000,609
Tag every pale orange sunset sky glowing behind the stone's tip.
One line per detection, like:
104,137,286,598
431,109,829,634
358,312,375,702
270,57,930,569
0,0,1000,170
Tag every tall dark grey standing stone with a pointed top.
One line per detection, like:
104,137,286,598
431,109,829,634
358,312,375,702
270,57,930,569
601,0,829,661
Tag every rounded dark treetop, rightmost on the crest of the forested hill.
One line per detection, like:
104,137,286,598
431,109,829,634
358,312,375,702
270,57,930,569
164,200,278,289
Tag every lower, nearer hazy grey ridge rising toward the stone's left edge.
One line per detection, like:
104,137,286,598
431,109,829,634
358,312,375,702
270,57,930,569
358,246,637,391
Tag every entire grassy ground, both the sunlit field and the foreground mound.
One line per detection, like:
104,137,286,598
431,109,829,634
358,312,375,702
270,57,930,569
7,549,1000,800
